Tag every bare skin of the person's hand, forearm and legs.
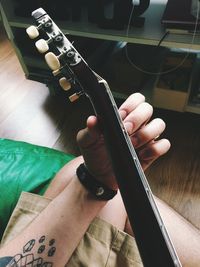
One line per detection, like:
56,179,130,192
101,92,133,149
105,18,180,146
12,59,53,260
0,94,200,267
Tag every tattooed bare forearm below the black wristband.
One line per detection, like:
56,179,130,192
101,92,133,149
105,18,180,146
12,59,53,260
0,177,106,266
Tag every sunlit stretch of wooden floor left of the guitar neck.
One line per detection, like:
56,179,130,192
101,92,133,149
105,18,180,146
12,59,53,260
0,25,90,154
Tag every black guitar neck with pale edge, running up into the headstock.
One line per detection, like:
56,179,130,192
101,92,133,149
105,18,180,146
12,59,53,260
29,8,181,267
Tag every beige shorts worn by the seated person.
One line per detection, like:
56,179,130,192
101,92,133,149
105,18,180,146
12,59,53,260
2,192,143,267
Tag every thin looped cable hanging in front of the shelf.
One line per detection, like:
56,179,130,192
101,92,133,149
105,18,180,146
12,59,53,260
125,0,200,75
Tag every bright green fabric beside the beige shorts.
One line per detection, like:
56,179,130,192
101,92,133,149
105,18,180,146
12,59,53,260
0,139,74,240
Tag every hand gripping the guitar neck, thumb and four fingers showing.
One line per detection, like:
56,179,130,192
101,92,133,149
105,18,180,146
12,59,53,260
77,93,170,189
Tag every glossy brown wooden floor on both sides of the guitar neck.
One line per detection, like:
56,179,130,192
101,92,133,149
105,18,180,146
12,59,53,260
0,24,200,231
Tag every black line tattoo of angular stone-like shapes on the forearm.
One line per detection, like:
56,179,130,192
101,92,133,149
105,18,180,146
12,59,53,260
0,236,56,267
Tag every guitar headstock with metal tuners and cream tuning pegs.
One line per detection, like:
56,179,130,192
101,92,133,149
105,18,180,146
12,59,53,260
26,8,84,102
